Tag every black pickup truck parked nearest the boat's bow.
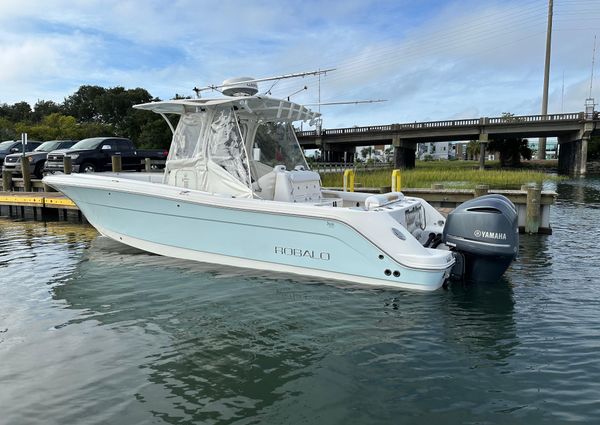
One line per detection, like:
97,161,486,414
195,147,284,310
44,137,168,173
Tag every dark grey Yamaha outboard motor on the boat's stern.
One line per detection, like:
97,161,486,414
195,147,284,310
443,195,519,282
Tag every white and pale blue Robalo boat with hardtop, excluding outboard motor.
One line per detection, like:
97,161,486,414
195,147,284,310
44,78,516,290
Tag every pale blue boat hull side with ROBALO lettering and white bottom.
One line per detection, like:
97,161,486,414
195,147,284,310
45,176,452,291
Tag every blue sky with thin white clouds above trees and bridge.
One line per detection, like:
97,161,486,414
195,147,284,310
0,0,600,129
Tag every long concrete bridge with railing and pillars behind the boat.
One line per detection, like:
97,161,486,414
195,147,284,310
296,112,600,175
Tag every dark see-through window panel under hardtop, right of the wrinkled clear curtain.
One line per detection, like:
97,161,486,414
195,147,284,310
252,123,308,177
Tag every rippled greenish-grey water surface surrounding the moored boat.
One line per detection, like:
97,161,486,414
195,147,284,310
0,178,600,425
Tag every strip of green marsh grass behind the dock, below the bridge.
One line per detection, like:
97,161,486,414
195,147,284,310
321,161,563,189
